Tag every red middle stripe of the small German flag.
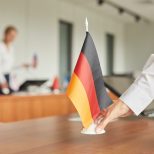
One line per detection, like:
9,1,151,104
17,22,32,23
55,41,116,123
74,52,100,120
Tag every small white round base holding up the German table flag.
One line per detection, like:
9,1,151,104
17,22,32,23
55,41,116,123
81,123,105,135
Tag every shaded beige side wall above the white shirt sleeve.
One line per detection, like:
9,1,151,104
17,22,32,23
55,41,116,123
124,23,154,72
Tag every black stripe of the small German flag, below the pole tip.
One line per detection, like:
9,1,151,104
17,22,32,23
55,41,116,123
81,32,112,109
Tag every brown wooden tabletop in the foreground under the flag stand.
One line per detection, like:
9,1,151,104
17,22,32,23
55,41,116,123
0,117,154,154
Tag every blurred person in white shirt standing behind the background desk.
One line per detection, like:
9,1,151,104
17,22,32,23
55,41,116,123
0,26,30,94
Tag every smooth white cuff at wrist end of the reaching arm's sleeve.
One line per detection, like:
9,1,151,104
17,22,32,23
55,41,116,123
120,84,153,115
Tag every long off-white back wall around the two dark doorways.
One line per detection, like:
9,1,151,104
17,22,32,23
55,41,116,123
0,0,125,78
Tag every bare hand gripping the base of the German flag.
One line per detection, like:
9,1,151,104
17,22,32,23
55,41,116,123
95,99,133,133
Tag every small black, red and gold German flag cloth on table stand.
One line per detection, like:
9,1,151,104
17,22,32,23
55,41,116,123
67,32,112,128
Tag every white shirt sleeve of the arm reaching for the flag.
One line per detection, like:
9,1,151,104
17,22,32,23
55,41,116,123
120,54,154,115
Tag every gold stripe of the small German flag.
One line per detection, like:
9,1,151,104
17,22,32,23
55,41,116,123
67,73,93,128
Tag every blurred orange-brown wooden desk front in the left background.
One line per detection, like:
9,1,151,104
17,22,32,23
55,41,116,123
0,94,76,122
